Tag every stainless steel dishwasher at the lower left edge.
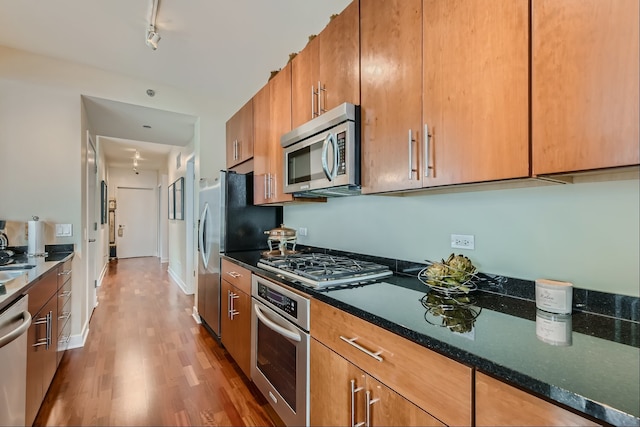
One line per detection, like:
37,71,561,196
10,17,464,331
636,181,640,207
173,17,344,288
0,295,31,426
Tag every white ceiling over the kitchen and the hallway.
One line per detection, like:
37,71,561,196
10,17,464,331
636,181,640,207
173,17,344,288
0,0,351,169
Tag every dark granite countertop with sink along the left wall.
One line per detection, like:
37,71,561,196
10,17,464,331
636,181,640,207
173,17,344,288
0,245,74,311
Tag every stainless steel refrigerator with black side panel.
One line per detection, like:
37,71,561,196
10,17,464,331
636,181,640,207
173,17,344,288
198,171,282,337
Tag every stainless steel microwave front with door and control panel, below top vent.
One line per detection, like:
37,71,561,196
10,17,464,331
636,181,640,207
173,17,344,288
284,122,360,193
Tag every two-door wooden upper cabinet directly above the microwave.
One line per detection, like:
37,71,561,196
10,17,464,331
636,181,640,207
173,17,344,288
291,0,360,128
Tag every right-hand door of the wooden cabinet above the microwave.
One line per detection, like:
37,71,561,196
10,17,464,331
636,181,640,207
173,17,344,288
319,0,360,113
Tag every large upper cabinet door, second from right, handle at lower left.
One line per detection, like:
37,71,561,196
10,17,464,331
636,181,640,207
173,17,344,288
421,0,529,187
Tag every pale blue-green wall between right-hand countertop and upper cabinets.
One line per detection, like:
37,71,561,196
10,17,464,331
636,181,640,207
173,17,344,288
285,179,640,296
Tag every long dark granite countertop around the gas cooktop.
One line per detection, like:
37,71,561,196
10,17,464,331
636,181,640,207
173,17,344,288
225,251,640,426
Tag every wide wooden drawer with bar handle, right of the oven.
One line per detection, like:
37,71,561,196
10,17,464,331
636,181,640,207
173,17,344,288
310,300,473,425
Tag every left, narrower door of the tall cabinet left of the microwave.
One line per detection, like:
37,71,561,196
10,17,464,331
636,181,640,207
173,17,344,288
253,83,272,205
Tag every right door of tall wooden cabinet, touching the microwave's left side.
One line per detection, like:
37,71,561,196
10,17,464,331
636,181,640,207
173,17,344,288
268,63,293,203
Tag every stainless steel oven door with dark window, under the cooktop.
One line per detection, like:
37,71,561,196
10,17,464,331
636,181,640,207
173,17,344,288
251,298,309,426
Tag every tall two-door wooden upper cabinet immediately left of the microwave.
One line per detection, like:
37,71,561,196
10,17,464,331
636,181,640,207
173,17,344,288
253,63,293,205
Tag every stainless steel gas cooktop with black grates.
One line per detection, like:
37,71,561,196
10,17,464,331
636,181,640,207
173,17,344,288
258,253,393,288
